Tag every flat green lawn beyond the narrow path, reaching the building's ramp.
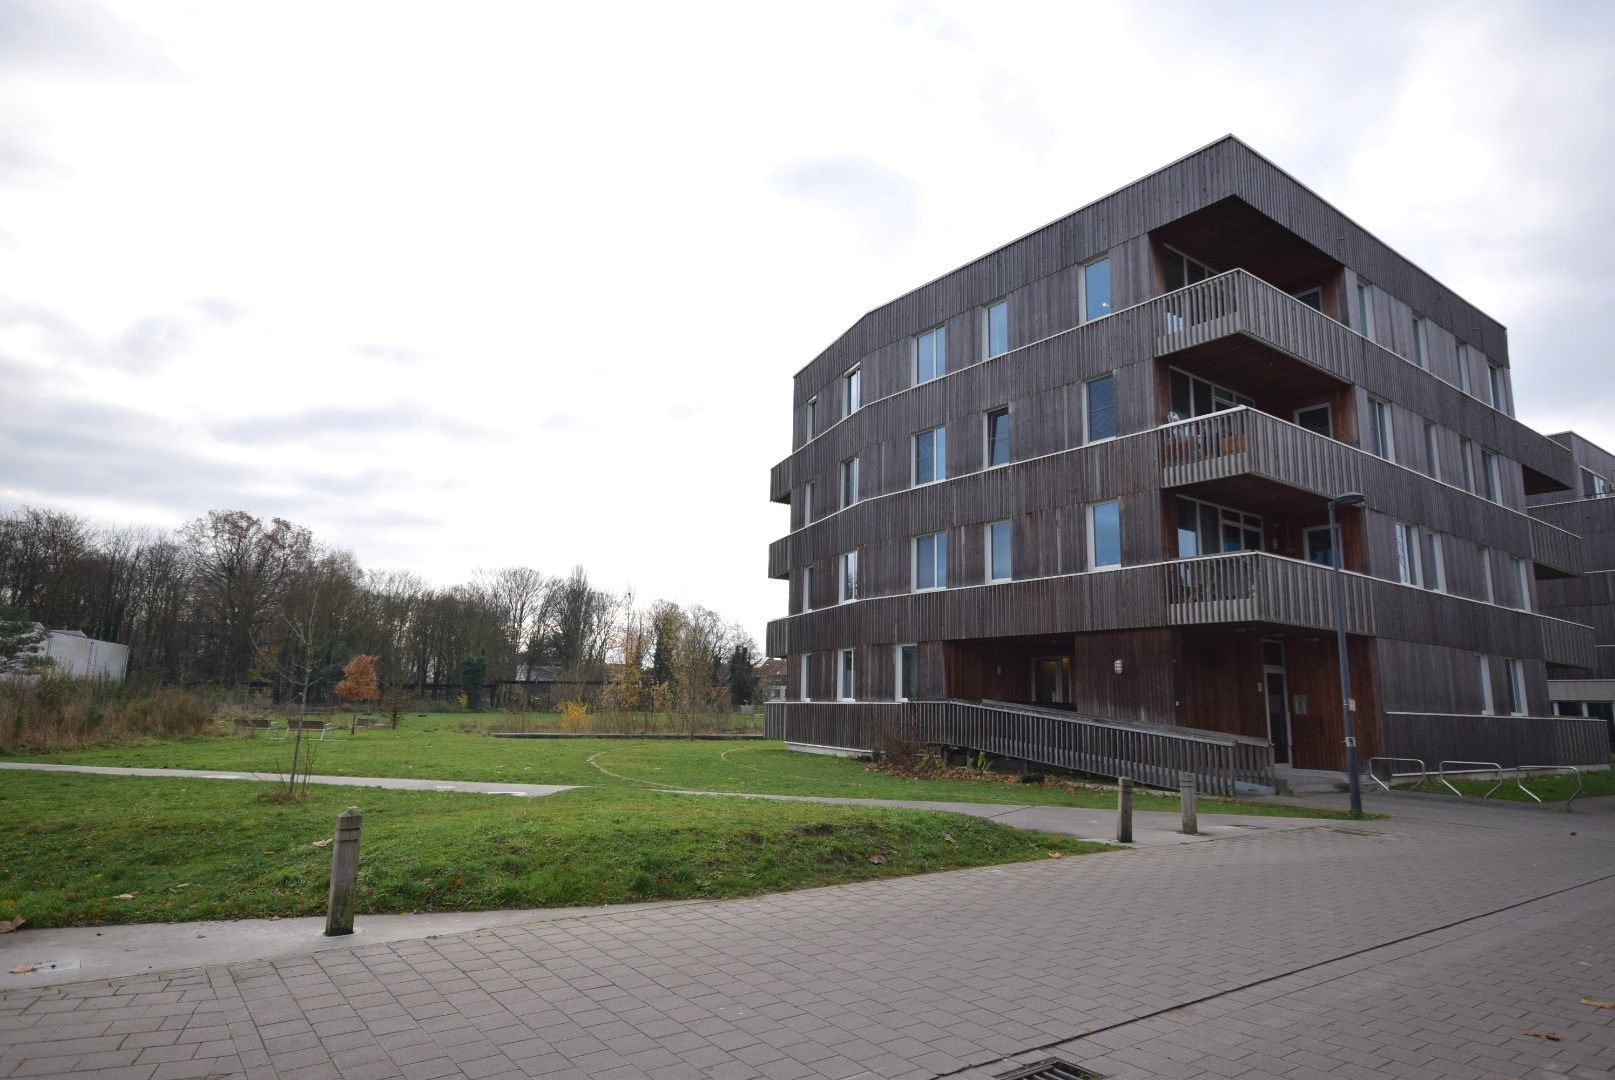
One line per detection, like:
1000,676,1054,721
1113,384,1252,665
5,714,1347,817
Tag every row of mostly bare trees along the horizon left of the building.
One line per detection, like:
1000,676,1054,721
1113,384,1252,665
0,507,761,709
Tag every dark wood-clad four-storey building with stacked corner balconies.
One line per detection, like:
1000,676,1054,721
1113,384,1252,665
767,137,1594,767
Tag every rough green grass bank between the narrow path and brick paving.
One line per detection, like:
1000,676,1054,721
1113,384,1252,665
0,773,1103,927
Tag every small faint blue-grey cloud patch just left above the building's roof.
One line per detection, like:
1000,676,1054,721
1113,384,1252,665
769,155,919,253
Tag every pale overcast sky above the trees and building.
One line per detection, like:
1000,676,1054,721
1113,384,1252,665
0,0,1615,641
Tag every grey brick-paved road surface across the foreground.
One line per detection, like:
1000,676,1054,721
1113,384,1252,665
0,801,1615,1080
